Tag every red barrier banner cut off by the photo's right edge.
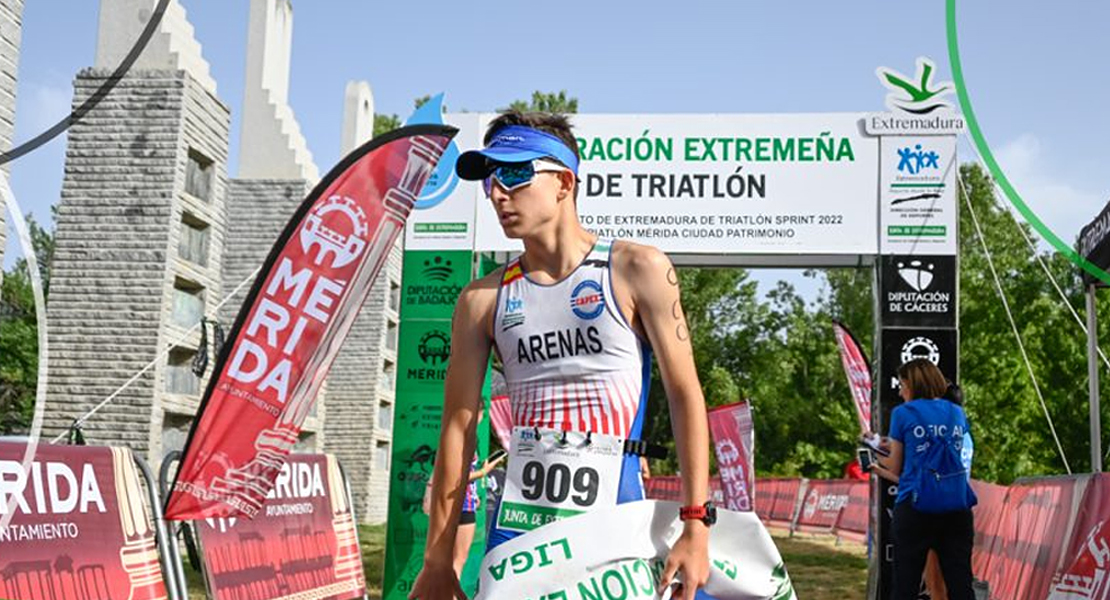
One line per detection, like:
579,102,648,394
1048,474,1110,600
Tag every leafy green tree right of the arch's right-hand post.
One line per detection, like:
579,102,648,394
959,165,1107,484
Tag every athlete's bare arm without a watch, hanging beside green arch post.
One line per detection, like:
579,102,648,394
408,277,497,600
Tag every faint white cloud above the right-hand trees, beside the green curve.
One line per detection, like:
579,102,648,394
995,133,1107,247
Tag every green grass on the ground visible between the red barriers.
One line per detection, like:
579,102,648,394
185,525,867,600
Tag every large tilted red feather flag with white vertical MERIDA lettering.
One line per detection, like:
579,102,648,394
165,125,455,519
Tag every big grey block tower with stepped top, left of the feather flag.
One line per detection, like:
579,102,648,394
44,0,231,464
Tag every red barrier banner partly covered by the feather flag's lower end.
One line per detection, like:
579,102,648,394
196,455,366,600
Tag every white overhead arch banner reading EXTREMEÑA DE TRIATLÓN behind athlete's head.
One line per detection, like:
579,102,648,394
406,113,879,255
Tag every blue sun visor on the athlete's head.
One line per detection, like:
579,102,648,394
455,125,578,181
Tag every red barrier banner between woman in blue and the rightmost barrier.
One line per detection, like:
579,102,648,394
972,478,1087,600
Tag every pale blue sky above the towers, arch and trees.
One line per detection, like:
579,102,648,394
8,0,1110,295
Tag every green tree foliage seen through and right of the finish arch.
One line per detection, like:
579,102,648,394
646,165,1110,482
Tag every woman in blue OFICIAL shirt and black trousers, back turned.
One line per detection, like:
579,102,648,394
875,358,975,600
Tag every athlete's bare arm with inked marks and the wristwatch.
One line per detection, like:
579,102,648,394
614,243,709,600
